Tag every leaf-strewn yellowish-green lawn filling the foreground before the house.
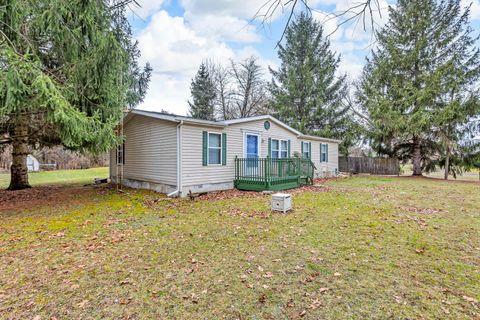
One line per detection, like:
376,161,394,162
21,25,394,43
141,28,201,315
0,177,480,319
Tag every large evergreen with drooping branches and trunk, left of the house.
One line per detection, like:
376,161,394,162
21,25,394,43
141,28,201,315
0,0,150,190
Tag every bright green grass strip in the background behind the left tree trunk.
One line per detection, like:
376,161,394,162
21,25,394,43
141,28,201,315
0,167,108,189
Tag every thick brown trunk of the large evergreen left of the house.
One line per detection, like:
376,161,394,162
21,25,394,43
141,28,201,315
7,114,31,190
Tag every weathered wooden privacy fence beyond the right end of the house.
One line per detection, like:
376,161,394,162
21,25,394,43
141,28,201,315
338,157,400,175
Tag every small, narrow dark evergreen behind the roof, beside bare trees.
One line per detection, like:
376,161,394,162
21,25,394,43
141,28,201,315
188,62,215,120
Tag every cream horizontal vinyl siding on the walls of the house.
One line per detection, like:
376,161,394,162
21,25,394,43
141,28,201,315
110,115,338,194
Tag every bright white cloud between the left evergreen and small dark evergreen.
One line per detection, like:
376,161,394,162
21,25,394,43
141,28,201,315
138,11,235,114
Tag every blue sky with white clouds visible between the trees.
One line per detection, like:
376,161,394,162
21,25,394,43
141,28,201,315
129,0,480,115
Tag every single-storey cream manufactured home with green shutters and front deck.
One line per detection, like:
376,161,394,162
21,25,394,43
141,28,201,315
110,110,340,196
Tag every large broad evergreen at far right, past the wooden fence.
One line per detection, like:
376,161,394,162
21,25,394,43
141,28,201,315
358,0,480,175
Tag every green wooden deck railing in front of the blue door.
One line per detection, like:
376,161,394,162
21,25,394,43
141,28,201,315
235,157,315,190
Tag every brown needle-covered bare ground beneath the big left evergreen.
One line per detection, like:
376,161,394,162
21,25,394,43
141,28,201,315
0,185,93,212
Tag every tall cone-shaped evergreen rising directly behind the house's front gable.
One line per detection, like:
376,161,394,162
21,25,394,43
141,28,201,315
270,12,352,151
